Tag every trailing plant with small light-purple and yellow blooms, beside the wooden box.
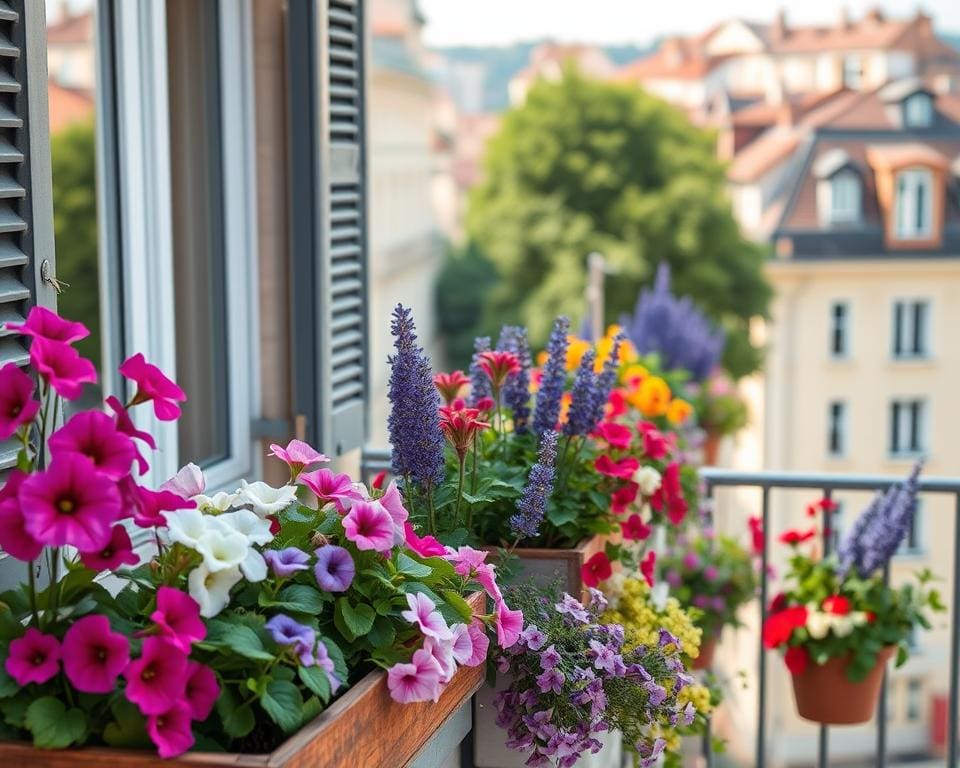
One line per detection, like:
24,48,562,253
495,585,696,767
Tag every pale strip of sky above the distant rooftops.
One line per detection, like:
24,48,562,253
418,0,960,46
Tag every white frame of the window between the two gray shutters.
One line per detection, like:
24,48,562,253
98,0,261,490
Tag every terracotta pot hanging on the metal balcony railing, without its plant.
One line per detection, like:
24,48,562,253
793,646,896,725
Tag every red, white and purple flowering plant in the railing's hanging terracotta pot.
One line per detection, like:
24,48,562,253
763,464,944,681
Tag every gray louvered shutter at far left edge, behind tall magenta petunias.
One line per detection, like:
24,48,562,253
0,0,56,470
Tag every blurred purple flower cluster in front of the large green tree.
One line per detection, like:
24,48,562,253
620,262,725,381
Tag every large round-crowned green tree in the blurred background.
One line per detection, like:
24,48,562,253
467,70,770,376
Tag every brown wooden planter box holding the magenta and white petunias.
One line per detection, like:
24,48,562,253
0,592,486,768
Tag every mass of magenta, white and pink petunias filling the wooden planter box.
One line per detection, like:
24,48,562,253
0,307,510,757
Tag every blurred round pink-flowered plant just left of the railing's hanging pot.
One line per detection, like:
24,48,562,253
662,528,757,636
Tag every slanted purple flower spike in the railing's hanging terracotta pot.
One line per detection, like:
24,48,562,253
837,462,923,577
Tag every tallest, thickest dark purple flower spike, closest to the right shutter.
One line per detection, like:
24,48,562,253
387,304,444,488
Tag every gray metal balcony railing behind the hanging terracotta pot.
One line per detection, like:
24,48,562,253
700,467,960,768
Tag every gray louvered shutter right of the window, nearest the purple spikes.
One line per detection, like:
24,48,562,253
288,0,367,456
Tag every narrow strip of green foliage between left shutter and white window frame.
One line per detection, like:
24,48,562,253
50,121,100,368
